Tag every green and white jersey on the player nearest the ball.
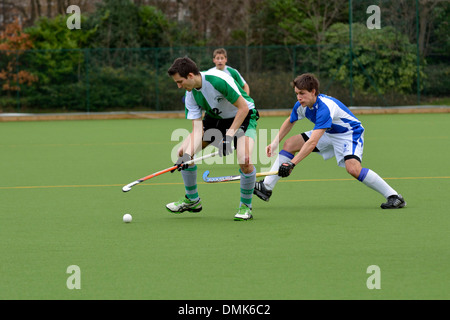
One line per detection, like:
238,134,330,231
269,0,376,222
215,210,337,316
185,69,255,119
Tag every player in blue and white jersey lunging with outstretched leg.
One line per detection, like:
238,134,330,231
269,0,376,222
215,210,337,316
254,73,406,209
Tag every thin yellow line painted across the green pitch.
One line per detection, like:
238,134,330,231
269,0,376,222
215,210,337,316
0,176,450,189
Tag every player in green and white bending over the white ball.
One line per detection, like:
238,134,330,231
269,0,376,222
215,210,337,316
166,58,259,221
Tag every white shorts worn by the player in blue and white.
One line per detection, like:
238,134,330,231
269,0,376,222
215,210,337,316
305,130,364,167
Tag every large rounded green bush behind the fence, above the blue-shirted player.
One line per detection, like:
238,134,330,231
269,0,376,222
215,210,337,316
323,23,417,94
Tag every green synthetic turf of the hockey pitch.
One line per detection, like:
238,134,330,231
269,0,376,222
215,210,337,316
0,114,450,300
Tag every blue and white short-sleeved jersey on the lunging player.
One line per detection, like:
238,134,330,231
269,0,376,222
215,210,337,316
290,94,364,135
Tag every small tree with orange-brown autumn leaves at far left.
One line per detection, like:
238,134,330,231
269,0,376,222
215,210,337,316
0,19,38,94
